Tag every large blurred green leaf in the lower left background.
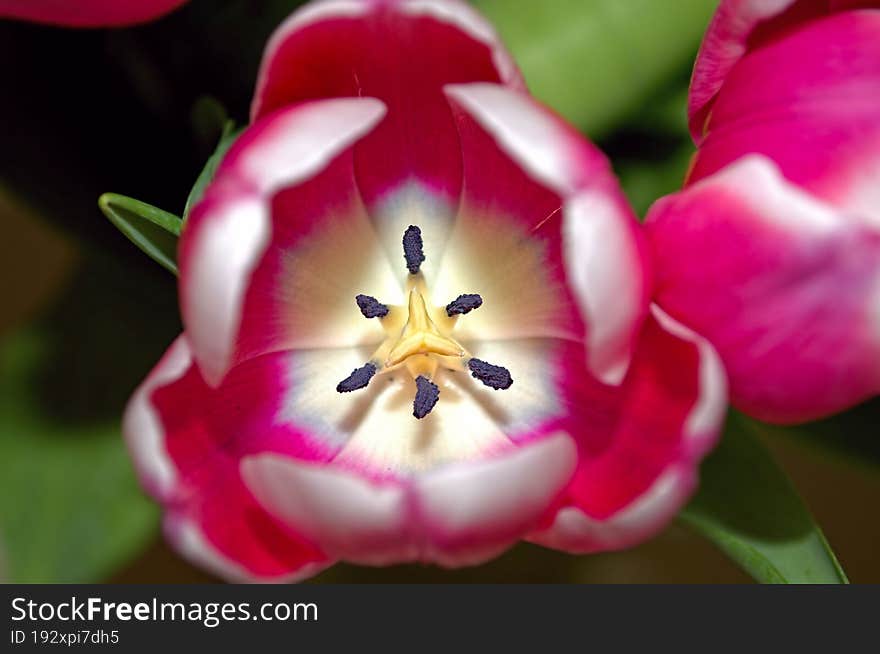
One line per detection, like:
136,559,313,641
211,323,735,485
0,331,158,583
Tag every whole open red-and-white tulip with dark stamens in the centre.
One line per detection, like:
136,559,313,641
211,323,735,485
125,0,726,580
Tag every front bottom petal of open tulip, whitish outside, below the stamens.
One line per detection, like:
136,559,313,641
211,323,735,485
242,435,574,566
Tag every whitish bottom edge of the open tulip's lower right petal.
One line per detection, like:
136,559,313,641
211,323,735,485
528,466,695,554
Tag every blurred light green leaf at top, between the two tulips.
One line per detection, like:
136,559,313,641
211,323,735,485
474,0,718,137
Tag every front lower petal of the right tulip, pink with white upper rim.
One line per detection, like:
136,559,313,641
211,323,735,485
647,155,880,423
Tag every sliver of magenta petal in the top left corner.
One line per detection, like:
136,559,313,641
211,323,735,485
0,0,187,27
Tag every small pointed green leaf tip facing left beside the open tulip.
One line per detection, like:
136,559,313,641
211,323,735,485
98,193,183,275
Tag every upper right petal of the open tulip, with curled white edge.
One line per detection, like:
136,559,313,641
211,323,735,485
438,84,649,382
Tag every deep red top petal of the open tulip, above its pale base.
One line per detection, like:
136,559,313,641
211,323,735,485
251,0,523,209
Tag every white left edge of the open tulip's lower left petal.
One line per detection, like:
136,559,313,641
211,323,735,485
122,335,192,500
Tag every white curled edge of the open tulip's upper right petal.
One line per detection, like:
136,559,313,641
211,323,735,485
445,83,645,385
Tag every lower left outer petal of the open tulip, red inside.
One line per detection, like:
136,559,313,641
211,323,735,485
124,337,328,581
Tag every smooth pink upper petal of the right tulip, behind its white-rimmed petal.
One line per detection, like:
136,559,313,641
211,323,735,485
690,10,880,225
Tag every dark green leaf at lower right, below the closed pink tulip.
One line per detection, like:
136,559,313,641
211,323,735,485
681,415,848,584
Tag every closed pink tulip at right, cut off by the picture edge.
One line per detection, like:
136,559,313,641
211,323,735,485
648,0,880,423
